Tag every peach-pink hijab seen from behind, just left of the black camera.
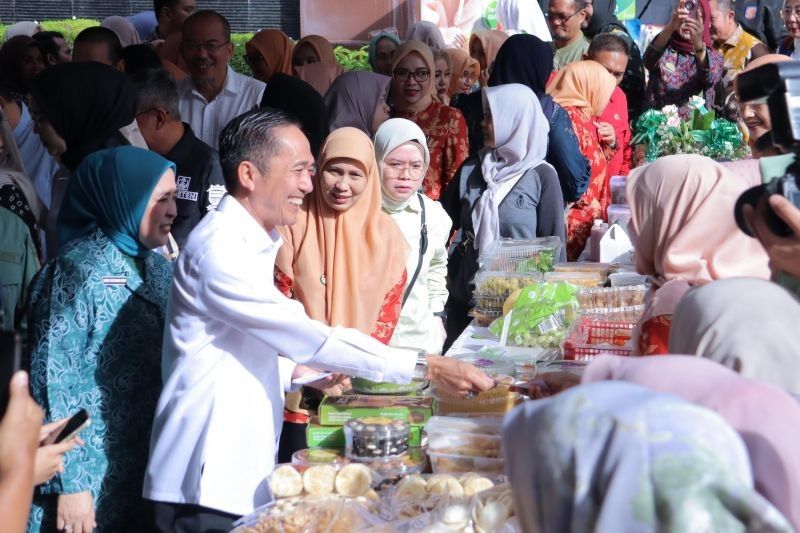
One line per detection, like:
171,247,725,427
627,155,770,287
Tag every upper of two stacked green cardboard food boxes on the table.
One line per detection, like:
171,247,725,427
319,395,433,426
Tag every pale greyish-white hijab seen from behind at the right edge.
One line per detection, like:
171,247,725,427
669,278,800,395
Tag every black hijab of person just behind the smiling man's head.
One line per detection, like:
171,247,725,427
261,72,328,158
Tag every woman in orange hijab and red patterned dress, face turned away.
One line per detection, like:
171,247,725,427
547,61,617,261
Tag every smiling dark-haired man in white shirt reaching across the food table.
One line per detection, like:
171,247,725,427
144,111,494,531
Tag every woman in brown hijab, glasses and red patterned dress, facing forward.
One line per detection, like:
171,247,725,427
391,41,469,200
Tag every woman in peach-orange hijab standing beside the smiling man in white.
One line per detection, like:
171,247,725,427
275,128,409,343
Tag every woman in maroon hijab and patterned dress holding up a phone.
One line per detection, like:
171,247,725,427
644,0,723,120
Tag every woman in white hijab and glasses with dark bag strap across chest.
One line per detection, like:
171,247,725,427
375,118,452,353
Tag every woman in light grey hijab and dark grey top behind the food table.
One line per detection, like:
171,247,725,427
442,83,565,339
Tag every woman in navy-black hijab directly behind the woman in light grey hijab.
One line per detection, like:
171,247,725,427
450,34,591,202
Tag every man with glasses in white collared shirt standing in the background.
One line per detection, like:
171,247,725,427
178,11,266,148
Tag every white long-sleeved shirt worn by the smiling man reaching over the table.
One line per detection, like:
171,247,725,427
143,196,416,515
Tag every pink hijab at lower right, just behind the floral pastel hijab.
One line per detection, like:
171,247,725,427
581,355,800,530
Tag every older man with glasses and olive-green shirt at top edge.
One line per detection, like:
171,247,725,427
547,0,589,70
